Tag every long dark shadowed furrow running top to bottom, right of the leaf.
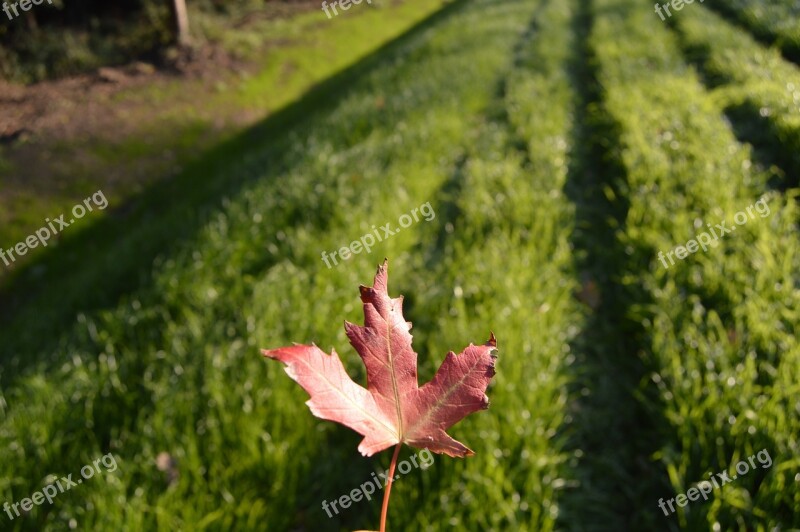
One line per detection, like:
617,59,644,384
560,1,669,530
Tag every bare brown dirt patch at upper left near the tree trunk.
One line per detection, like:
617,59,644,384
0,0,319,193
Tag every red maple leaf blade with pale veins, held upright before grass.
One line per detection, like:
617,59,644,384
262,261,497,457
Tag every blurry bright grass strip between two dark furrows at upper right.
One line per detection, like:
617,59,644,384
671,2,800,187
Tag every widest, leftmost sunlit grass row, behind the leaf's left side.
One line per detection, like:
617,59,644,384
0,0,552,530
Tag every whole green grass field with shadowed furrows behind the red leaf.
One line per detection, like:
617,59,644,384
0,0,800,531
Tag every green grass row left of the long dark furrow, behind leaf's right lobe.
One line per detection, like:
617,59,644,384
390,1,583,531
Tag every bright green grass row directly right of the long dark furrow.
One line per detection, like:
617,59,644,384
591,0,800,530
